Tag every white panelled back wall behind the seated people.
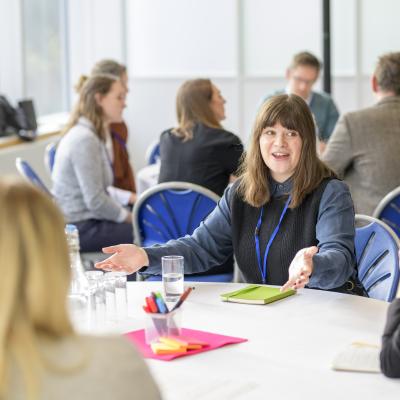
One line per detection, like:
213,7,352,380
125,0,400,169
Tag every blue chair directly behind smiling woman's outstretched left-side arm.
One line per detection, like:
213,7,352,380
133,182,233,282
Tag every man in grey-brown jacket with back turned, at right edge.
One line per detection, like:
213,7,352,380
322,52,400,215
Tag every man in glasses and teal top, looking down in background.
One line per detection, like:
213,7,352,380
264,51,339,153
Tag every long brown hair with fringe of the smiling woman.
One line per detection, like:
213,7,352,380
238,94,336,208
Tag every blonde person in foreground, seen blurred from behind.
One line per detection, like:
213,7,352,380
0,177,160,400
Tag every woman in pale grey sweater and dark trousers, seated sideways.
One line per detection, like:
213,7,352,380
52,75,135,251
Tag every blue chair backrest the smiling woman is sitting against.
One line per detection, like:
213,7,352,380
355,214,400,301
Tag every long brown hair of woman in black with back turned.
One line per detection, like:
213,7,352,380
172,79,222,141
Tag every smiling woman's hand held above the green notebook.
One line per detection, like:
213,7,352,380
281,246,318,292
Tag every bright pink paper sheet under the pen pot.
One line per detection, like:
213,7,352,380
125,328,247,361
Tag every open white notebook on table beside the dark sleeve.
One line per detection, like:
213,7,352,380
332,342,381,373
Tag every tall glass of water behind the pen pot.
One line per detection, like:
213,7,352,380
161,256,184,302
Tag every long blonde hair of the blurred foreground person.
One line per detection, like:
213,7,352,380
0,177,74,399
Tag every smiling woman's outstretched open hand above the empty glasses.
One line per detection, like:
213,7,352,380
95,244,149,274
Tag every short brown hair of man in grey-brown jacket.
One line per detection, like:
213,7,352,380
374,52,400,96
